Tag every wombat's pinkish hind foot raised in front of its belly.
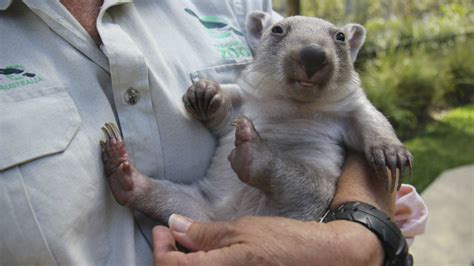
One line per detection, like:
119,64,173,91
228,116,269,186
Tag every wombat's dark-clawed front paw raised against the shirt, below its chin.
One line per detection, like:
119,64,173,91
182,80,225,121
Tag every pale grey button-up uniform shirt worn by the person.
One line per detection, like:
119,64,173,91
0,0,271,265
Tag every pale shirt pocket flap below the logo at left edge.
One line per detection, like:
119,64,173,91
0,86,81,170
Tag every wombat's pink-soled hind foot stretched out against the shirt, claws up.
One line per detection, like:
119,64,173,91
100,123,150,207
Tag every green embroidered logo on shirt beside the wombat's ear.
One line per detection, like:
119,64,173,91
184,8,252,60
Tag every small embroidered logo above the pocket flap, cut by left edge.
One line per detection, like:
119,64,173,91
0,65,44,90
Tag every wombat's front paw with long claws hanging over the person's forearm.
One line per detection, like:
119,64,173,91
366,142,413,191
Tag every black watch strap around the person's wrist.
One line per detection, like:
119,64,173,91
322,202,413,266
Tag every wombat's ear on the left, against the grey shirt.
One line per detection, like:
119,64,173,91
245,11,273,53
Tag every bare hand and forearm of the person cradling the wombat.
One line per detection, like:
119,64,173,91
153,155,395,265
